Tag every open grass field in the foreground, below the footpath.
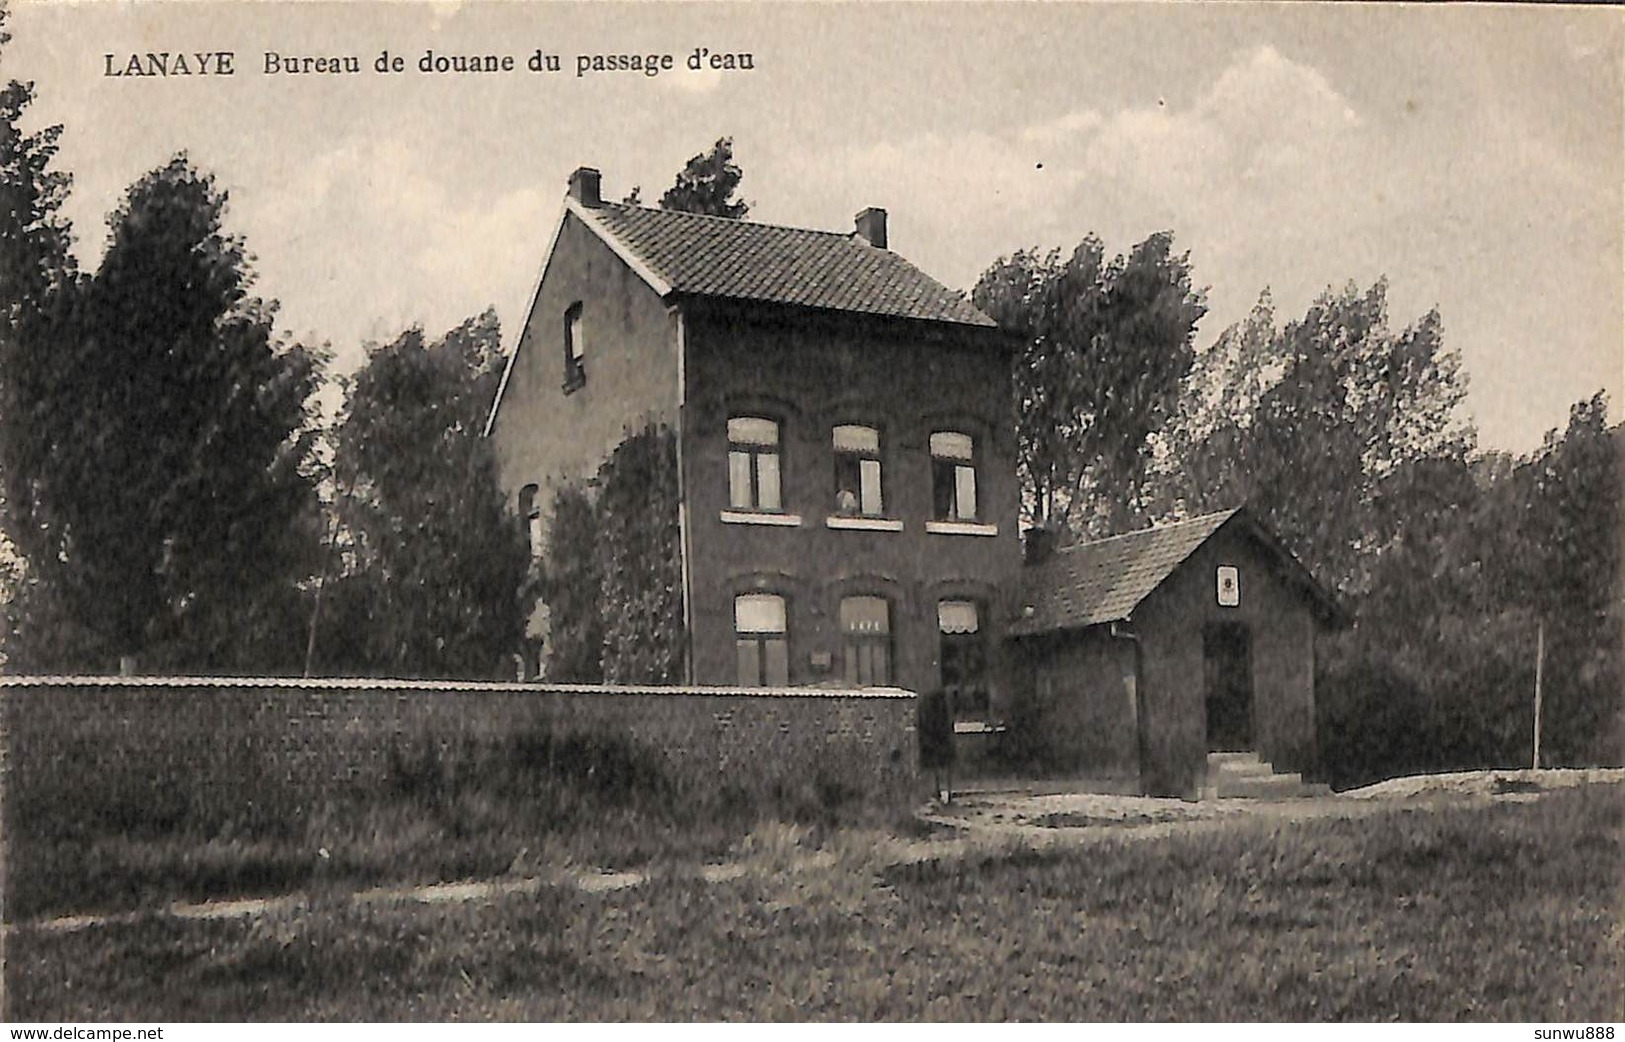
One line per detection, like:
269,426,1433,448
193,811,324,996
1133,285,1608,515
7,785,1625,1022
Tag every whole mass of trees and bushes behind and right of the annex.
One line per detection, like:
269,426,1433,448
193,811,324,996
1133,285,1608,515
1147,281,1622,784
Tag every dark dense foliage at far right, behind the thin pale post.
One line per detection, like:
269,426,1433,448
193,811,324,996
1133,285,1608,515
1320,395,1625,782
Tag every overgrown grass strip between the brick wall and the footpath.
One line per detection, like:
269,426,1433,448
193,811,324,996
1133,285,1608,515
7,721,877,922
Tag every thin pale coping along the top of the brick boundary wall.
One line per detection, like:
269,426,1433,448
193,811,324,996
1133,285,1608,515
0,675,917,699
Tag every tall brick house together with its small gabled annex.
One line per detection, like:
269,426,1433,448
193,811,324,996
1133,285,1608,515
486,169,1336,793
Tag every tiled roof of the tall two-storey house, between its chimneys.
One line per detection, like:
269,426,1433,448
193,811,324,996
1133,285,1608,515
575,203,995,328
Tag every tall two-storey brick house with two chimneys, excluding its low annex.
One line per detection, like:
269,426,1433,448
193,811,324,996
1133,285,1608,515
488,169,1021,719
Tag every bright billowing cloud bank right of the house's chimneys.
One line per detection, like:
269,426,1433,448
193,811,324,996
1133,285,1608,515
764,46,1367,300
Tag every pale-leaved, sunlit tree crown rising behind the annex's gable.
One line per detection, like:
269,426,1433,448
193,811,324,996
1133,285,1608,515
1157,281,1474,593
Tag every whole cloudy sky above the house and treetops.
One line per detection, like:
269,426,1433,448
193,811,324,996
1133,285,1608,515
0,0,1625,452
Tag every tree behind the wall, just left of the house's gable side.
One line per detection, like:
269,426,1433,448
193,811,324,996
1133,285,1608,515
325,310,528,679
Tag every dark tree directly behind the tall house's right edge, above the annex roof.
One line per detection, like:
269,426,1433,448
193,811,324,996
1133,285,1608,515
972,232,1207,533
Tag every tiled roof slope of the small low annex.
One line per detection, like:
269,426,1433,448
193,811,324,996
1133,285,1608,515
1011,510,1237,636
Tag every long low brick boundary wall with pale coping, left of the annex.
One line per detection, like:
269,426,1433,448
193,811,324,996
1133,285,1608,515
0,676,923,834
